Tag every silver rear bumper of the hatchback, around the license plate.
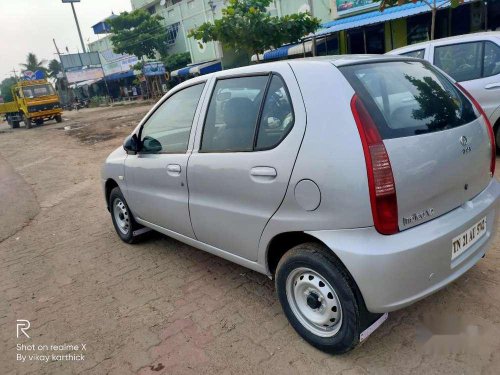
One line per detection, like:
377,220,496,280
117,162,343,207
307,179,500,313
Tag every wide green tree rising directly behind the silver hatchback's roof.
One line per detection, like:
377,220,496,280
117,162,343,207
188,0,320,59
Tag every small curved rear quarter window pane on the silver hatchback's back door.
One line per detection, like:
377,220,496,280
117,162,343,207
256,75,294,150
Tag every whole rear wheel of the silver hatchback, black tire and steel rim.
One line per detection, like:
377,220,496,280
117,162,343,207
276,243,360,354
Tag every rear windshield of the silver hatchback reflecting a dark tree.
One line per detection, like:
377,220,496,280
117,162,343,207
340,61,478,139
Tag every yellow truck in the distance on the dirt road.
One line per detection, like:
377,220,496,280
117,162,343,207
0,79,62,129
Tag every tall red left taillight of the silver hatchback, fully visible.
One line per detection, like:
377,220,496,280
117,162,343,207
351,95,399,234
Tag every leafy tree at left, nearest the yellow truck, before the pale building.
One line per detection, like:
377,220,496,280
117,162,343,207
106,9,168,58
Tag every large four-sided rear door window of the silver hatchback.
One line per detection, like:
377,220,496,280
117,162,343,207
200,75,269,152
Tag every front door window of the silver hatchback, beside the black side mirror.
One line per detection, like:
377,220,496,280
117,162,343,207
141,83,205,154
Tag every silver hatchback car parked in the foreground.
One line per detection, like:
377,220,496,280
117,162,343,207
102,56,500,353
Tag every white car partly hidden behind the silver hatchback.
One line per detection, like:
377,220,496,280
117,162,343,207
387,31,500,151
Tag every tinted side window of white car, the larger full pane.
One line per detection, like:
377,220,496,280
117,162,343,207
434,42,483,82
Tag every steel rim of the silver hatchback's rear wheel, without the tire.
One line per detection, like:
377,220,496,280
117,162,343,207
286,267,342,337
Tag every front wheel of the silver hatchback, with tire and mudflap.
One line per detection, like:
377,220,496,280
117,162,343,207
109,187,144,244
